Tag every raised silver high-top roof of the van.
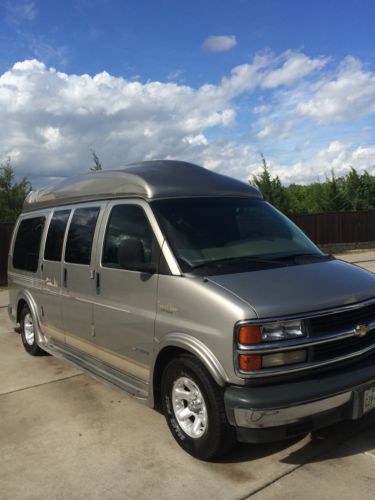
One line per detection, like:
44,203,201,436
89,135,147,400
24,160,262,212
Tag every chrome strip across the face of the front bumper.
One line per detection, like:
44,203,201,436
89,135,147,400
234,392,352,429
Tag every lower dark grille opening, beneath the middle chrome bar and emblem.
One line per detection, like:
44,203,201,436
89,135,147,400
313,329,375,361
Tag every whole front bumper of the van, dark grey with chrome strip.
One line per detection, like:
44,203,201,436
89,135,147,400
224,357,375,442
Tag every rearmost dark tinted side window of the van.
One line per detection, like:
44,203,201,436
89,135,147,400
13,217,45,273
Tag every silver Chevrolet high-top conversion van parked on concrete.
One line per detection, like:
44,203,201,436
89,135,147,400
9,161,375,459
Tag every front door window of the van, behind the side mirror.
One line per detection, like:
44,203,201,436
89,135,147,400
102,205,156,268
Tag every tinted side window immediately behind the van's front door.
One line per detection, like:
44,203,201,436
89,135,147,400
65,207,100,265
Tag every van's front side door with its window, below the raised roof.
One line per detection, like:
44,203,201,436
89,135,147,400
94,200,160,381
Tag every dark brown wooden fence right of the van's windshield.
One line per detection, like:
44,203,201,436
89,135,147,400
291,211,375,245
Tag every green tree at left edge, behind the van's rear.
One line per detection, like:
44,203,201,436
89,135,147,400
0,158,31,222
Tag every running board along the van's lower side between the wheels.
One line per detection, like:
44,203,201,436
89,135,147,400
42,339,148,404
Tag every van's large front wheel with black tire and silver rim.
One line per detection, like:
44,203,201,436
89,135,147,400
161,355,236,460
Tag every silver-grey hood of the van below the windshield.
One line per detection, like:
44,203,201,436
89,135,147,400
207,260,375,318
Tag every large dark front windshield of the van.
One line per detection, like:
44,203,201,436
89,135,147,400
152,198,324,274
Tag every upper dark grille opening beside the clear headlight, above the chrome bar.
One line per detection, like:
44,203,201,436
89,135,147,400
310,304,375,337
